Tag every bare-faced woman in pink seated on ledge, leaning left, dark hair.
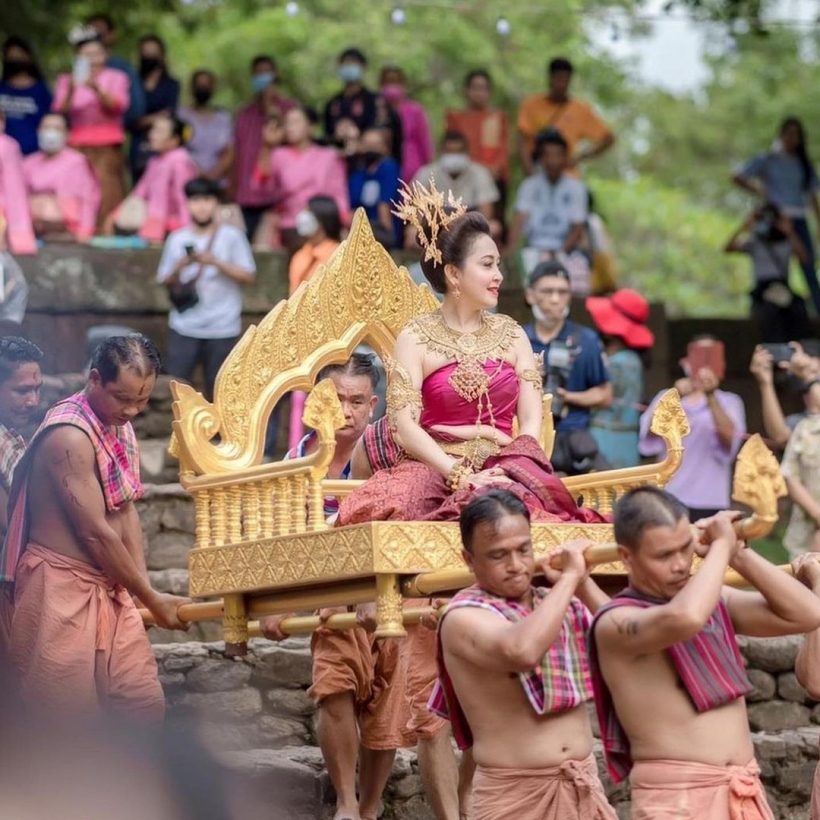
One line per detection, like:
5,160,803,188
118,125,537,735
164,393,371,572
106,117,199,243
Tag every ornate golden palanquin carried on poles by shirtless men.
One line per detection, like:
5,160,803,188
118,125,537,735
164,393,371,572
172,211,688,648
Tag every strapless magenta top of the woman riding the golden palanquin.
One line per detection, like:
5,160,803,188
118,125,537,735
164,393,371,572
419,359,520,438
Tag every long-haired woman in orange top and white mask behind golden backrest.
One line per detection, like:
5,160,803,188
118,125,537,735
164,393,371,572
288,196,342,449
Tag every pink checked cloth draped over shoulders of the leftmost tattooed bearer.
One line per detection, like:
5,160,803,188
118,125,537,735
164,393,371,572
0,392,143,582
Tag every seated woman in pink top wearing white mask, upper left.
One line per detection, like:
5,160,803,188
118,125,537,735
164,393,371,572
23,112,100,242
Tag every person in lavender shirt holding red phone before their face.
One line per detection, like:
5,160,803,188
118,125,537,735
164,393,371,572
639,336,746,521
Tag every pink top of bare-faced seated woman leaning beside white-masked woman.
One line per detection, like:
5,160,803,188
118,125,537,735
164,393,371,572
131,148,199,242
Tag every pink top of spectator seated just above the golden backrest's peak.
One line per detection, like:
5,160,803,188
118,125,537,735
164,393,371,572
262,145,350,229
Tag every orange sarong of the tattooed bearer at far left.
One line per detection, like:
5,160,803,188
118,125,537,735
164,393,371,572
9,542,165,723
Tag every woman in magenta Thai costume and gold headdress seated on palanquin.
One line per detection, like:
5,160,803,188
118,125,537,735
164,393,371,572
337,179,606,525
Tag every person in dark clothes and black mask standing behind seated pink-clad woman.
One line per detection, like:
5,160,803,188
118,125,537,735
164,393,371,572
129,34,179,183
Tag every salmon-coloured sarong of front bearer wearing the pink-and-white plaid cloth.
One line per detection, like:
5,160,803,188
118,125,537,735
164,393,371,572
470,755,617,820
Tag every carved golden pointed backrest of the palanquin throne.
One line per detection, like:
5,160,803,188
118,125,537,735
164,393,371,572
171,209,438,480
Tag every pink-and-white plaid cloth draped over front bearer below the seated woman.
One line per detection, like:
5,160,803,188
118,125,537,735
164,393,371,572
429,585,592,749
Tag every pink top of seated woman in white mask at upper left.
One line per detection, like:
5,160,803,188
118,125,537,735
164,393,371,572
23,148,100,239
